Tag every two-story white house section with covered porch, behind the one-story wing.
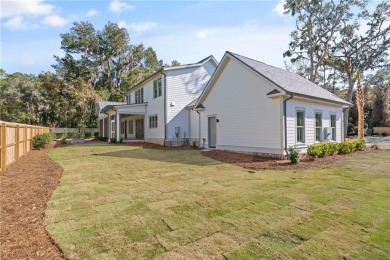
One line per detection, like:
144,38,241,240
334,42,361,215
98,56,218,145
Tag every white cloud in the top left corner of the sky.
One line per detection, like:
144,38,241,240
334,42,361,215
0,0,54,18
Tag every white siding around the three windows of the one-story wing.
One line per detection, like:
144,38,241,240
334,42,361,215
287,98,343,151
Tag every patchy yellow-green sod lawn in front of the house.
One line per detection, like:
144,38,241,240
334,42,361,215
46,145,390,259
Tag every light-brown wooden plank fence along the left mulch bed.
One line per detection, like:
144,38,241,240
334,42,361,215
0,121,49,173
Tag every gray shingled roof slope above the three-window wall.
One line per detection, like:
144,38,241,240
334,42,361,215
228,52,351,105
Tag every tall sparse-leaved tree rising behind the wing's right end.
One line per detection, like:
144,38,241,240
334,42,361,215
285,0,390,137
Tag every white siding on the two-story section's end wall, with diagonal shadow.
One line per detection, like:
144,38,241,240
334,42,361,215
166,61,215,139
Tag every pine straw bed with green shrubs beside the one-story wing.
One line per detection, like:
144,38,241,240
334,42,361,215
202,148,388,170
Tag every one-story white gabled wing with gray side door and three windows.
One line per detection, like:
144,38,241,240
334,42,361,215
195,52,351,157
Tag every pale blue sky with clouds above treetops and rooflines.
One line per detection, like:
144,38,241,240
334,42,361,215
0,0,295,75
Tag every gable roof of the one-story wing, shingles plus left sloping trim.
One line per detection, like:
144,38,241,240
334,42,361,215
196,51,351,106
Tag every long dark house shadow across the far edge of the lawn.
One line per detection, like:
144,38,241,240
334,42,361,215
92,148,224,166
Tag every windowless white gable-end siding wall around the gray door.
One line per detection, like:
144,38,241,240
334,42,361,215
201,60,283,154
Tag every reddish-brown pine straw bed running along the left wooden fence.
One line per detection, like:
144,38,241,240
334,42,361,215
0,144,66,259
